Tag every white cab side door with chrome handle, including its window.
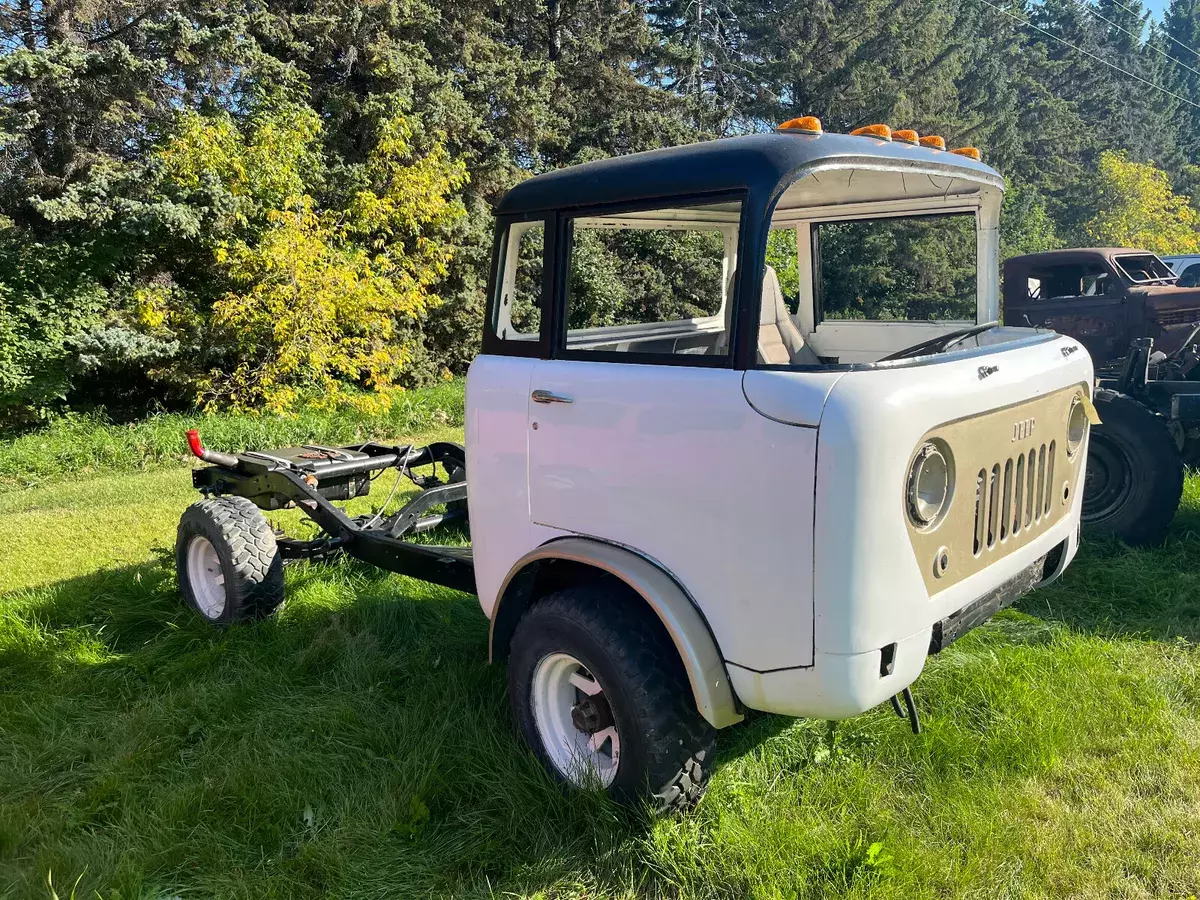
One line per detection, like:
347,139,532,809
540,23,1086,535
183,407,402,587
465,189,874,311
527,204,816,671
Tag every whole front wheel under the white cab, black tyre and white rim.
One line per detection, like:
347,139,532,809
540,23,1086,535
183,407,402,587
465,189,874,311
509,581,715,811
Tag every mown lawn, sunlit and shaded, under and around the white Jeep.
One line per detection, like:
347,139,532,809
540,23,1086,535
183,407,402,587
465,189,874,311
0,458,1200,900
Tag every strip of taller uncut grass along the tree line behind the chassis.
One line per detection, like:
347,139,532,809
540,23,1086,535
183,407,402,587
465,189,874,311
0,380,463,492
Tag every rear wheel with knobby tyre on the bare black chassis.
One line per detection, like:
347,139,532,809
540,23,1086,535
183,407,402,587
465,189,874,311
175,497,283,625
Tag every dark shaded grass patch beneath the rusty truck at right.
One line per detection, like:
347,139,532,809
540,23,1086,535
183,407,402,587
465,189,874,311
1019,509,1200,643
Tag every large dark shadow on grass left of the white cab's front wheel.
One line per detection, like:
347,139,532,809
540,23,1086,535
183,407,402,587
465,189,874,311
0,559,739,896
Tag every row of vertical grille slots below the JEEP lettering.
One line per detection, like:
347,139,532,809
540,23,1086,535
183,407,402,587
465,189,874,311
972,440,1058,557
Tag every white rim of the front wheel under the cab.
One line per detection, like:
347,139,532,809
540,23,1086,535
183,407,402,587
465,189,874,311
530,653,620,787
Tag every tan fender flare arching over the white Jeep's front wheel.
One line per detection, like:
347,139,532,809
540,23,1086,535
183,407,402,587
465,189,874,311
490,538,743,728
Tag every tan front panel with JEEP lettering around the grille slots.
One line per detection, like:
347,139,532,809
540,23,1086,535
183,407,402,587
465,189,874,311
904,385,1085,594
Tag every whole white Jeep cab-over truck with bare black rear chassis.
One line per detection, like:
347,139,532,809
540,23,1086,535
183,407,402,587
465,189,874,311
178,119,1092,808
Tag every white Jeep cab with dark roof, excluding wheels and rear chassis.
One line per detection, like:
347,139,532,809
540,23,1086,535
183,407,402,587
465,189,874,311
466,134,1093,721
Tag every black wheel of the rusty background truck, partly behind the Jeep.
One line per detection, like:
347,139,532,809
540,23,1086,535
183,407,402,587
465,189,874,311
1082,390,1183,547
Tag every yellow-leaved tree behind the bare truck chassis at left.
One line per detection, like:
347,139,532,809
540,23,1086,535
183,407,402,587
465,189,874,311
156,103,466,412
